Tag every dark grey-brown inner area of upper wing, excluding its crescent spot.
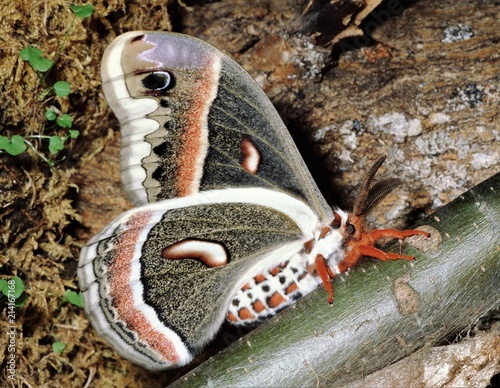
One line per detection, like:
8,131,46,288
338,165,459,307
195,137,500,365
200,61,316,203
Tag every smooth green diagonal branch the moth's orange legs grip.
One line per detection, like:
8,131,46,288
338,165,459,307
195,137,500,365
172,174,500,387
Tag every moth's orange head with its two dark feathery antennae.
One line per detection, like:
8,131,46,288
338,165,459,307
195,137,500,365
345,155,401,241
